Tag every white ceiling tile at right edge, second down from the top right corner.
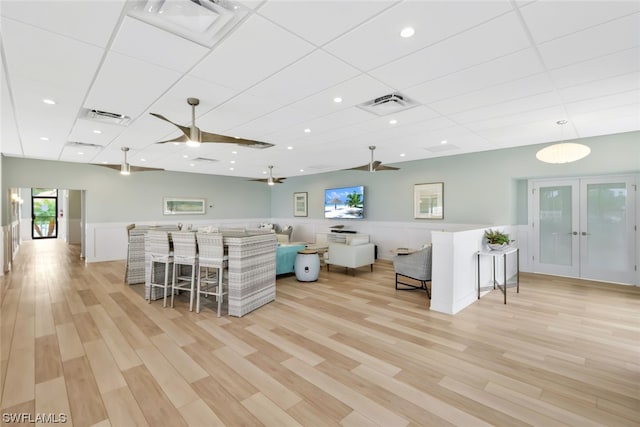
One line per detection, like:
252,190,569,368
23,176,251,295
538,13,640,69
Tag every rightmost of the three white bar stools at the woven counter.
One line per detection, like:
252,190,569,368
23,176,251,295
196,232,229,317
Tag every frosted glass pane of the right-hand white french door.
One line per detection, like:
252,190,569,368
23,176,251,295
582,182,632,271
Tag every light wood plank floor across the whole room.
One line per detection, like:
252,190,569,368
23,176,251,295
0,240,640,427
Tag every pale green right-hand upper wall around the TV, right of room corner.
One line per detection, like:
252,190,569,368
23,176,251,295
271,132,640,224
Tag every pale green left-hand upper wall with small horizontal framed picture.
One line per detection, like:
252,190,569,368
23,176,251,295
2,157,270,224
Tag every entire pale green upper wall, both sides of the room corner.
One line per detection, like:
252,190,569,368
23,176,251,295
0,132,640,224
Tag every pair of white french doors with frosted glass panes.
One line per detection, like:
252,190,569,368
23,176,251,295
531,176,636,284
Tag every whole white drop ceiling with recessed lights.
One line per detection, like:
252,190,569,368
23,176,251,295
0,0,640,178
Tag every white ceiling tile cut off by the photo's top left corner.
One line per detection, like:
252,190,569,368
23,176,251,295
0,0,126,47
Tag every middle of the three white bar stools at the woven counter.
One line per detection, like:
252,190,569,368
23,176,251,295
171,231,198,311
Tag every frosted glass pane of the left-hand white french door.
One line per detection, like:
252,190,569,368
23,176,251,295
538,185,573,265
